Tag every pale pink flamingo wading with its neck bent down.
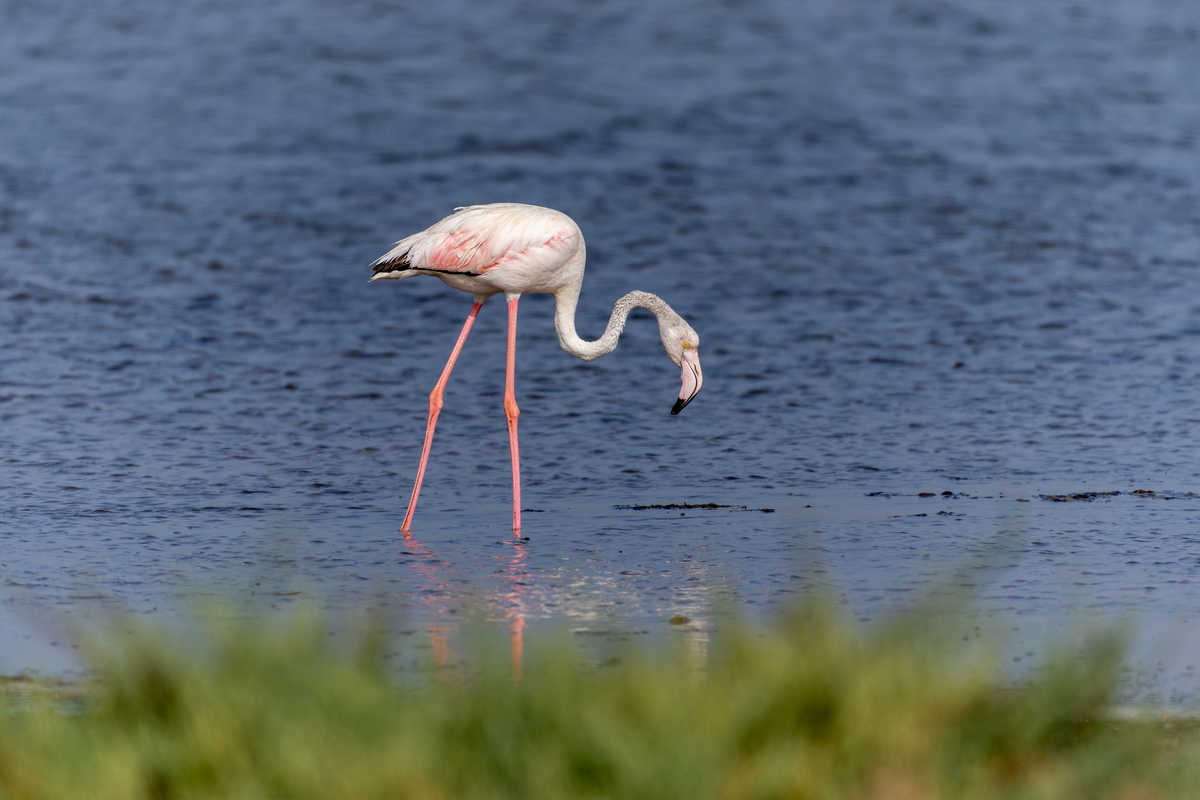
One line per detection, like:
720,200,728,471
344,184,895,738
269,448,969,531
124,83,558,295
371,203,703,537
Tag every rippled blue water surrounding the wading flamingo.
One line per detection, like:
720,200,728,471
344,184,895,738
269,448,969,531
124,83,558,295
0,0,1200,702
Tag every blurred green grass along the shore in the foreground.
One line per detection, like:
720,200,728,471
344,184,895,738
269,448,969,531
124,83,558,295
0,604,1200,800
